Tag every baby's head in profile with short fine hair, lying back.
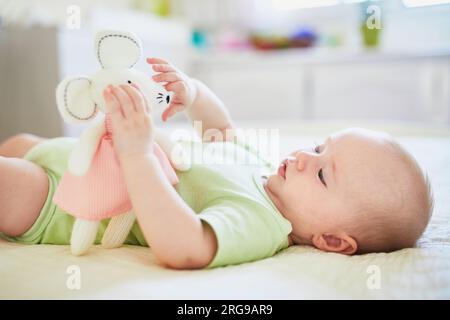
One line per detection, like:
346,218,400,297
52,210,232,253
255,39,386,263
265,128,433,254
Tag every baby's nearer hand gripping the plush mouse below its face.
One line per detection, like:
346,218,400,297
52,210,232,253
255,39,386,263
103,85,154,160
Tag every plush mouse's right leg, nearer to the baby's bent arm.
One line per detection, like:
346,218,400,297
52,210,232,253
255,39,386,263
102,211,136,249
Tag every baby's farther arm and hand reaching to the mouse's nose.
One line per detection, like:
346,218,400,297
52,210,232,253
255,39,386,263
147,58,233,140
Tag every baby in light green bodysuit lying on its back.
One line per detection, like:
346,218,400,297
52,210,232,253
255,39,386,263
0,58,433,269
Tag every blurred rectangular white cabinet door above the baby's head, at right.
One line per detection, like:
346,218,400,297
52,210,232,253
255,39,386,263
311,62,429,120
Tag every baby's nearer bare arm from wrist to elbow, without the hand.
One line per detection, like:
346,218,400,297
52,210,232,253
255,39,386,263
121,154,217,269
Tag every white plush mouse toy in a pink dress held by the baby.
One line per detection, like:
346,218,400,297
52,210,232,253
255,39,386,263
53,31,190,255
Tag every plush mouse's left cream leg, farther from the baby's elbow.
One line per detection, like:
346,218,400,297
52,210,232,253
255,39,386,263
70,219,100,256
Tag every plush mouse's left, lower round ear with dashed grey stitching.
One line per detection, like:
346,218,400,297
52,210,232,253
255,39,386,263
56,76,98,123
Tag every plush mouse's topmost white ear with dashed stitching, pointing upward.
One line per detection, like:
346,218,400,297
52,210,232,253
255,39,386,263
95,31,142,69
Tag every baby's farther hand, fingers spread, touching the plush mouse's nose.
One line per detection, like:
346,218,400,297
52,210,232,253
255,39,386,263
147,58,197,121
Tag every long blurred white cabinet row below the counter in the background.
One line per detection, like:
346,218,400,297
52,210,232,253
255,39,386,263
192,51,450,123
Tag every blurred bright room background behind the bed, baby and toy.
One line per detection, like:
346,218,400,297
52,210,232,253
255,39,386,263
0,0,450,140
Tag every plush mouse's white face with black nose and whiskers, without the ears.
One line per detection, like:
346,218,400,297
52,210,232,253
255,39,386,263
91,69,170,112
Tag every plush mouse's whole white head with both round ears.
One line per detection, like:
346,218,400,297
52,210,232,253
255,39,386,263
56,31,174,123
